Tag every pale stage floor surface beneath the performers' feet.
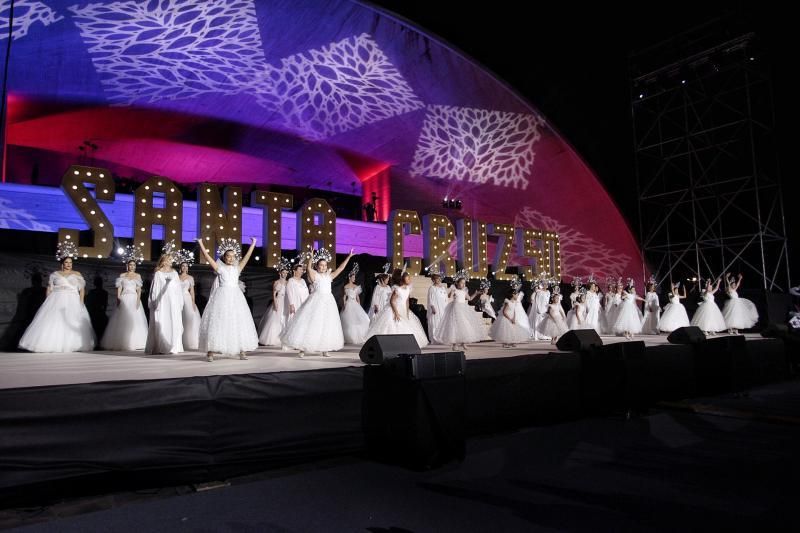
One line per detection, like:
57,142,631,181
0,334,762,389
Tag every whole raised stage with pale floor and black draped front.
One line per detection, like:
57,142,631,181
0,335,789,506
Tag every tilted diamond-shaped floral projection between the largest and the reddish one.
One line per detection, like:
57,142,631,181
258,34,424,138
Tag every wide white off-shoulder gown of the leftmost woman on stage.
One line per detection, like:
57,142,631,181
19,272,95,353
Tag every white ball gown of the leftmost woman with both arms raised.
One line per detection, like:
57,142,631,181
200,262,258,355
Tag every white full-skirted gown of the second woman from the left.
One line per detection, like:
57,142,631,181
100,275,147,351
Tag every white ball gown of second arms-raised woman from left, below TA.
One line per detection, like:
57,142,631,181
281,272,344,352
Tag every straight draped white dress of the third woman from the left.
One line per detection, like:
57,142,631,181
144,270,183,354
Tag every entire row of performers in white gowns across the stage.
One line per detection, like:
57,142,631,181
19,239,758,361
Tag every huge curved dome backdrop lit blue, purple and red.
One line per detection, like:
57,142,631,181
0,0,643,279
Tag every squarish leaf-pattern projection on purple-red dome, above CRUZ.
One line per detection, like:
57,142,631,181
411,105,543,189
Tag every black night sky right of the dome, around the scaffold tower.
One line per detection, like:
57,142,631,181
372,0,800,284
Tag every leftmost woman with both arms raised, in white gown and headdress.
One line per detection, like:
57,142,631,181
197,237,258,362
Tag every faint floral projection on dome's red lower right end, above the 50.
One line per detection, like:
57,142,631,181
514,207,631,279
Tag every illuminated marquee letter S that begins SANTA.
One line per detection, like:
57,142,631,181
58,166,115,258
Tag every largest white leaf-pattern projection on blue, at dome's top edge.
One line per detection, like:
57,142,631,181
69,0,266,103
